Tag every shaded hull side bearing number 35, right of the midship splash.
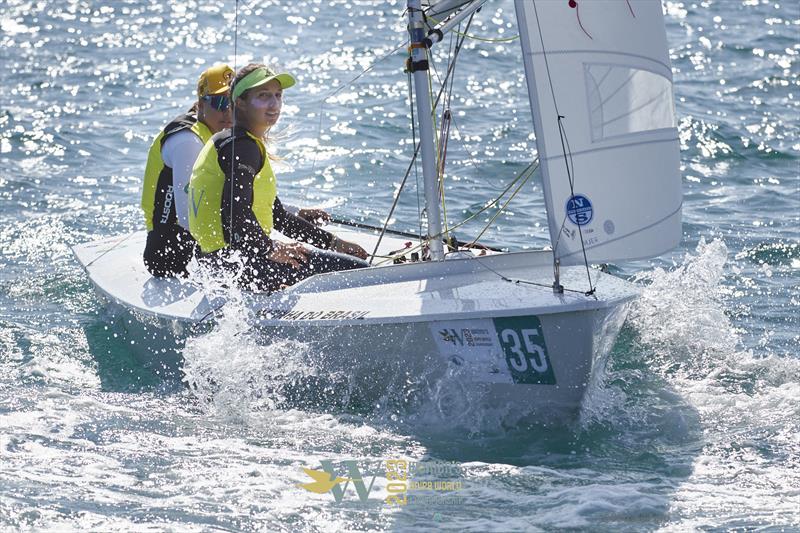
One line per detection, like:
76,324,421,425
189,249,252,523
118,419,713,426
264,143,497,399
250,303,628,423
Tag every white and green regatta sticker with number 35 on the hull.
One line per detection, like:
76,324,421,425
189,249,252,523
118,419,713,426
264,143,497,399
430,316,556,385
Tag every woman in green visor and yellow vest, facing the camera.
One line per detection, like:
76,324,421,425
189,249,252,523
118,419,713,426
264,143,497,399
189,64,367,292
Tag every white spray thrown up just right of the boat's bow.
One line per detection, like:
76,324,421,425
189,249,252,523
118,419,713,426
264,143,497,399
629,239,800,386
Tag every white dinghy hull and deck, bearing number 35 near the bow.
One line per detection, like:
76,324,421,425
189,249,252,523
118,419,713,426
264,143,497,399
75,231,636,424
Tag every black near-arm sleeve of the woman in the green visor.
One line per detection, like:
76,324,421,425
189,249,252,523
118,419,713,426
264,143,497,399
218,135,272,254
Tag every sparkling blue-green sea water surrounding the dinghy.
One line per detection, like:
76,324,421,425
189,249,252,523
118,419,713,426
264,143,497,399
0,0,800,532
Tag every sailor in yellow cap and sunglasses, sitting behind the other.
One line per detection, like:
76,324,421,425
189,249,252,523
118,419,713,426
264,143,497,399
142,64,234,277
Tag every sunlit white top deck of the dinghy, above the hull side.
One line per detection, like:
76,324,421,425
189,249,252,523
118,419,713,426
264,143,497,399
73,226,637,326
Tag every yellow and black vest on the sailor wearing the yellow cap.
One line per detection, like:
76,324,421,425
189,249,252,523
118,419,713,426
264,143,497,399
142,113,213,231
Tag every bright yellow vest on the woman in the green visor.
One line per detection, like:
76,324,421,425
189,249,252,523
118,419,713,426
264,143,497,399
189,130,278,253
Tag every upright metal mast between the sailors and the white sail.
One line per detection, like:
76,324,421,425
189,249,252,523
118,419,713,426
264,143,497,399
407,0,444,261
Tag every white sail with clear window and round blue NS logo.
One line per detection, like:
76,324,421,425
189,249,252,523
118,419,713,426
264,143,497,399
516,0,682,265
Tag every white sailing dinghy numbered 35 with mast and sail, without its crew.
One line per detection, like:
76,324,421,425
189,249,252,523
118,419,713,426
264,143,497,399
74,0,682,421
